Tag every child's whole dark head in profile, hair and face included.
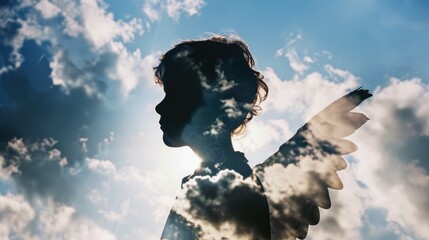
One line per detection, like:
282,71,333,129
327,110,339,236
155,36,268,146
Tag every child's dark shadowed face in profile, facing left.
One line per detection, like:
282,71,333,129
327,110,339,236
155,65,237,147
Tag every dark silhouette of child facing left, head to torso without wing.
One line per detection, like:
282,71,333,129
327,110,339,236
155,36,270,239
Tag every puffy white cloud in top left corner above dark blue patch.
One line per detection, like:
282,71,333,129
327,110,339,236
0,0,150,100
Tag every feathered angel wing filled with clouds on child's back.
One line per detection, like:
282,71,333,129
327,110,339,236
254,88,372,239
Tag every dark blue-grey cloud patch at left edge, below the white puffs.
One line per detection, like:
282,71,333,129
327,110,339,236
0,71,103,158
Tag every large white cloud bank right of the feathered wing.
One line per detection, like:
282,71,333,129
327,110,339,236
272,76,429,239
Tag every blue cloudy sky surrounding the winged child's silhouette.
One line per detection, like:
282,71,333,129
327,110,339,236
0,0,429,240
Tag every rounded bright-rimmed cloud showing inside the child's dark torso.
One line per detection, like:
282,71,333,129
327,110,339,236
167,170,268,239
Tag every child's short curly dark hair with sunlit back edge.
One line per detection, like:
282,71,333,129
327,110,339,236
154,35,268,135
